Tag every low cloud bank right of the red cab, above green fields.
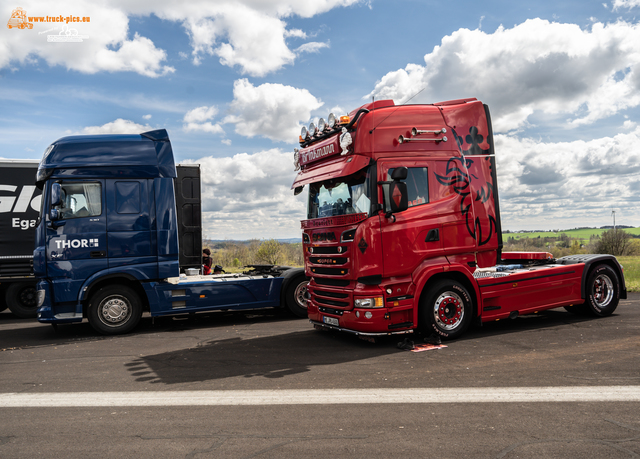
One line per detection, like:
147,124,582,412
495,128,640,230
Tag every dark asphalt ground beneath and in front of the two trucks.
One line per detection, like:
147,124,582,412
0,294,640,459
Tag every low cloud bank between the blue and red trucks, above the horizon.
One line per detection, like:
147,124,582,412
190,149,306,239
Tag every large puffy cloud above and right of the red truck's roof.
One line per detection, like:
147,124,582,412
365,19,640,132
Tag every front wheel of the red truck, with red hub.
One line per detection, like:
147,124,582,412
420,280,473,339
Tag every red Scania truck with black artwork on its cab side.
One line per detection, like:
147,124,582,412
292,99,626,339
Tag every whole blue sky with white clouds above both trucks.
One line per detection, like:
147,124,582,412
0,0,640,239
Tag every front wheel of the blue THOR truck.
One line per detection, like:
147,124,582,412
87,285,142,335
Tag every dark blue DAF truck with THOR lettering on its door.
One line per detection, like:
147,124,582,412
33,129,307,335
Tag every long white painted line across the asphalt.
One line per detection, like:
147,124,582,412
0,386,640,408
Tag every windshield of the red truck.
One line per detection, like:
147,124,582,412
307,167,371,219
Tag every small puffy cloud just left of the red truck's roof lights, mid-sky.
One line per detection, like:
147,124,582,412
224,79,323,143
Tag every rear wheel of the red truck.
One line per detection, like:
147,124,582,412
584,265,620,317
